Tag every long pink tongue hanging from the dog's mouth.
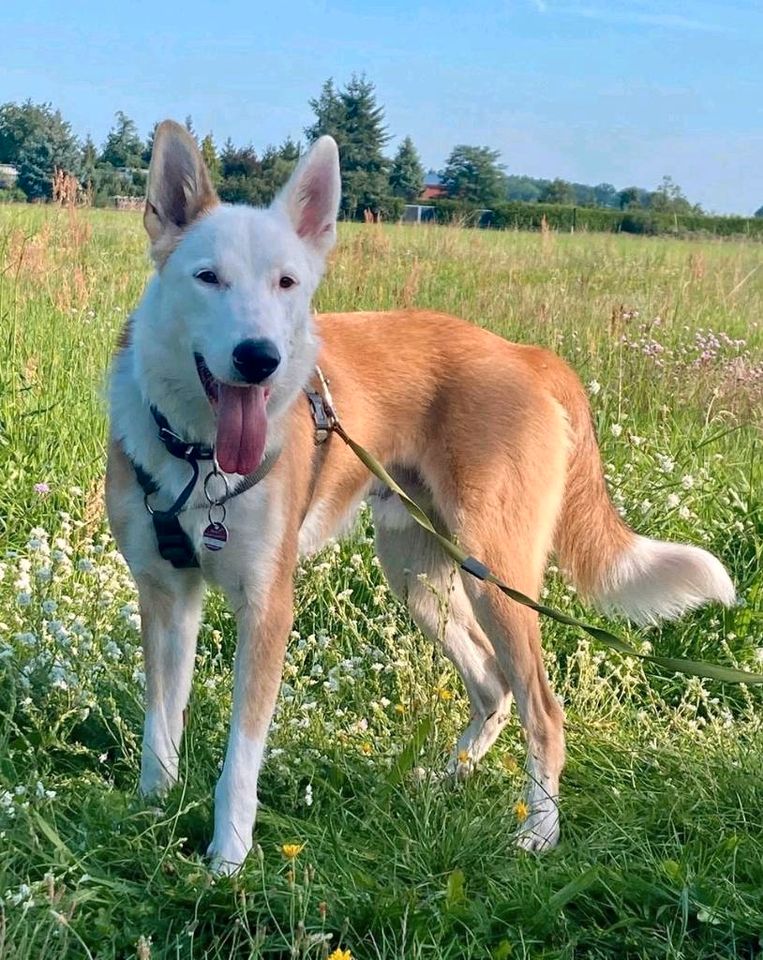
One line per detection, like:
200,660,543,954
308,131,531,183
215,383,268,474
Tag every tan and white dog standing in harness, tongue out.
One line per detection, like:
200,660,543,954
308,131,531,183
106,121,735,872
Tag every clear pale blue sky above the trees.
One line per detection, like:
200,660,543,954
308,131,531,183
0,0,763,214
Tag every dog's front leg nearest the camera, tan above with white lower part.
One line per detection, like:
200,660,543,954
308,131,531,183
208,569,293,873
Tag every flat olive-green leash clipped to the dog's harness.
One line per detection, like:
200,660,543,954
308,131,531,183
307,367,763,684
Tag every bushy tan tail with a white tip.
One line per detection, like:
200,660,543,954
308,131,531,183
554,364,736,624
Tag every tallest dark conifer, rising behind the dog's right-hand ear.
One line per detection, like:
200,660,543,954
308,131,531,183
305,74,389,217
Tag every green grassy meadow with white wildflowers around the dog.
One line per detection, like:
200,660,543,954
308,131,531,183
0,207,763,960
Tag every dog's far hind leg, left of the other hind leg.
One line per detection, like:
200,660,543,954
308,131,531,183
374,502,511,775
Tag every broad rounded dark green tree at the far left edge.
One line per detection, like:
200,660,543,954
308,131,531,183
0,100,80,200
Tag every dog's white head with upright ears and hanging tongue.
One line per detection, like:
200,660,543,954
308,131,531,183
142,120,340,474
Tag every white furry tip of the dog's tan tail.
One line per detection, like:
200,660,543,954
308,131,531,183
595,536,736,624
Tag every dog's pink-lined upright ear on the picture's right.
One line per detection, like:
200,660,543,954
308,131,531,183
274,137,342,256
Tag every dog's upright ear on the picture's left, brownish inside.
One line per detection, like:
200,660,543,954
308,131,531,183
143,120,219,266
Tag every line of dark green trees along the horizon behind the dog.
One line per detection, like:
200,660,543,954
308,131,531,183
0,75,763,219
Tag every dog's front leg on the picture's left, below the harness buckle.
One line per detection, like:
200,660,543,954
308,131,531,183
136,561,203,795
